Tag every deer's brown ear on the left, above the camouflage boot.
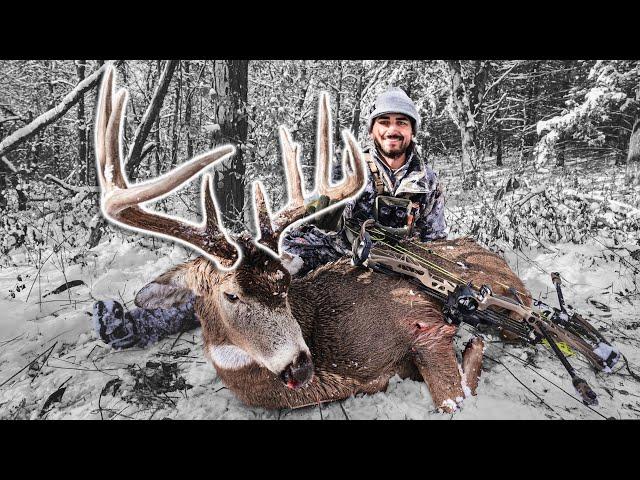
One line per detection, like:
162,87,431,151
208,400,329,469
134,265,194,308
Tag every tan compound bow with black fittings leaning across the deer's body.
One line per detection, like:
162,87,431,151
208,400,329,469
345,219,620,405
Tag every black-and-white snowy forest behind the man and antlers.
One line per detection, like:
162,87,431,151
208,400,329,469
0,60,640,262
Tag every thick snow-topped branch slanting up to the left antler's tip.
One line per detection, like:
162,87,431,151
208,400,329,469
0,62,105,157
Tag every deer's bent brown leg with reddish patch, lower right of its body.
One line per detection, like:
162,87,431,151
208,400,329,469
412,322,464,413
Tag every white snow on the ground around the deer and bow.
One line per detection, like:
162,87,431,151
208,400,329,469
0,229,640,420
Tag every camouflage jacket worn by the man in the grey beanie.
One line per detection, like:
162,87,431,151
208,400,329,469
343,143,447,241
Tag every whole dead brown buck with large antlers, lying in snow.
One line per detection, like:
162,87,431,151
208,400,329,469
96,66,508,411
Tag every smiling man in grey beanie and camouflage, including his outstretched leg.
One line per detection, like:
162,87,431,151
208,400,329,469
93,88,447,348
